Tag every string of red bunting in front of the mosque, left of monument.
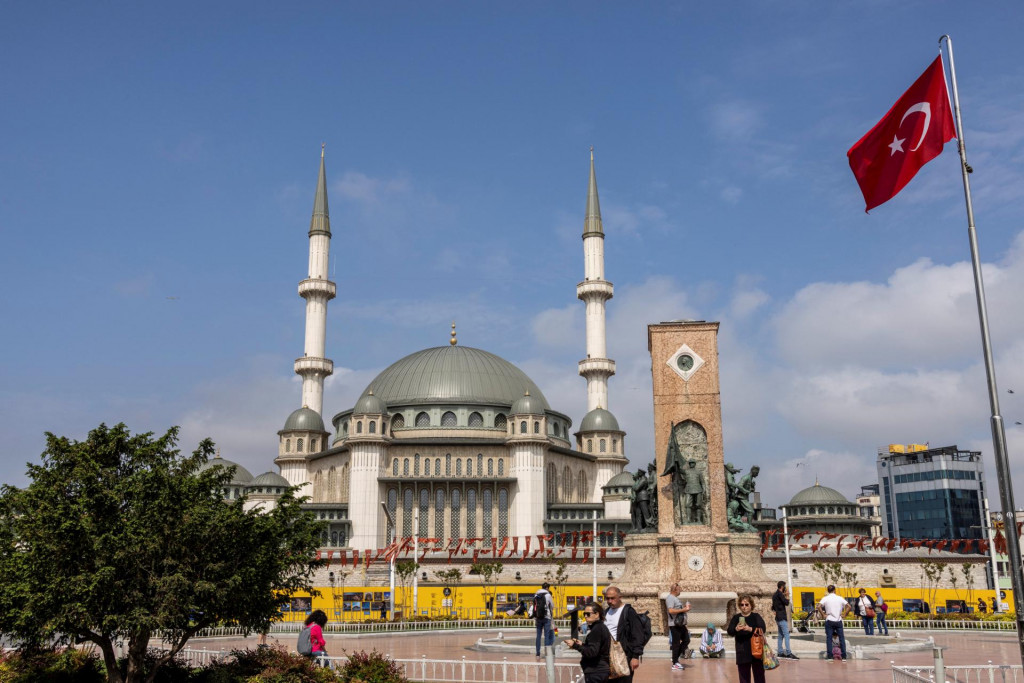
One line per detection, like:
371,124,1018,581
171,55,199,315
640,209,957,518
316,531,626,569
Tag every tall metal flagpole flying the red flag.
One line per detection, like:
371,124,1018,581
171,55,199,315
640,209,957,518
939,35,1024,661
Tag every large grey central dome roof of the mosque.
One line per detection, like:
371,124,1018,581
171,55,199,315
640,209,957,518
360,345,550,411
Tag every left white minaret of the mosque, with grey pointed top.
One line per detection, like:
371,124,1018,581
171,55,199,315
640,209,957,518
295,144,338,417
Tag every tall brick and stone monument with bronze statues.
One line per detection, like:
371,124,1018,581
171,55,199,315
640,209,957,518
616,321,775,632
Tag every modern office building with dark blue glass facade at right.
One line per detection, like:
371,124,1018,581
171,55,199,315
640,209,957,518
877,444,985,539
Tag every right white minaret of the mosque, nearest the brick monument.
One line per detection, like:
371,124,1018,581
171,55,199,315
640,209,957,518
577,147,615,413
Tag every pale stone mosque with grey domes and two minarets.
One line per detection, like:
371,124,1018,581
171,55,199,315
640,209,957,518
208,150,633,551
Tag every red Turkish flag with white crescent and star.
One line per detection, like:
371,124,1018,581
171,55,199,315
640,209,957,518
846,55,956,212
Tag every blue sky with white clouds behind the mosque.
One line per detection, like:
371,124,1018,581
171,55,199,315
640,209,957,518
6,1,1024,505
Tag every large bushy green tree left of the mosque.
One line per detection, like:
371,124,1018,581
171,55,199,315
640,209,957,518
0,424,322,683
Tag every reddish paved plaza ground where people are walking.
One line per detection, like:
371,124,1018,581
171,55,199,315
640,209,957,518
190,631,1020,683
